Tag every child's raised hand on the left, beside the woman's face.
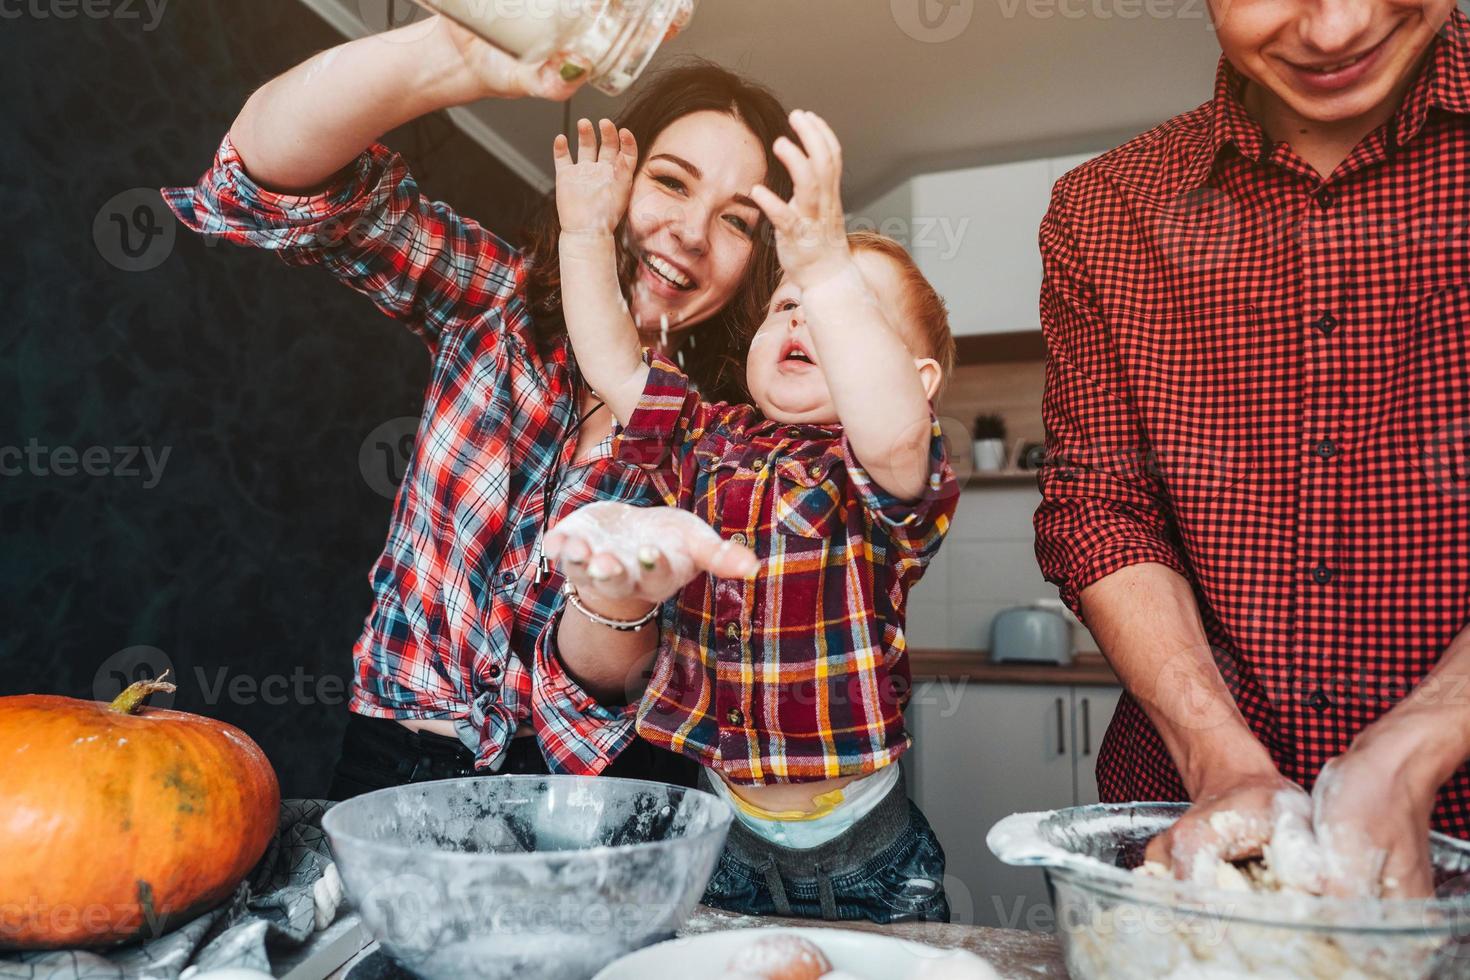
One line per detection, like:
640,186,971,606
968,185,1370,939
553,119,638,235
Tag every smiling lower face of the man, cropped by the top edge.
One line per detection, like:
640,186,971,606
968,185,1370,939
1210,0,1454,123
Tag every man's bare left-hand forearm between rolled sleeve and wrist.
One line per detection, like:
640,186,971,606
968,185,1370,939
1082,564,1276,799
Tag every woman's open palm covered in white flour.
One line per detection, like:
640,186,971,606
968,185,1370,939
544,501,760,605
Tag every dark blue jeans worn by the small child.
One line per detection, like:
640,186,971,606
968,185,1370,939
704,783,950,924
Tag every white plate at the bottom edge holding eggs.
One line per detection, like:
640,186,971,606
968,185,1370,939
592,929,987,980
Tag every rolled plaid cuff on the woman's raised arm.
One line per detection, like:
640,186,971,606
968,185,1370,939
162,135,401,250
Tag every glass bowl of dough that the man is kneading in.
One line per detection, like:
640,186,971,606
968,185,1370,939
986,804,1470,980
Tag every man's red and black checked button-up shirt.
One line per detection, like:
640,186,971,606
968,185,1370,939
1036,21,1470,836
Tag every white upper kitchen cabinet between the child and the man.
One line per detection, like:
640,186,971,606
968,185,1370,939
853,154,1094,336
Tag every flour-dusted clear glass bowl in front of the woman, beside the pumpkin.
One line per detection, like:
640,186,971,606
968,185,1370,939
322,776,732,980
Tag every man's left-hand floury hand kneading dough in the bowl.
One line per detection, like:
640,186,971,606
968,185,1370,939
1145,771,1322,893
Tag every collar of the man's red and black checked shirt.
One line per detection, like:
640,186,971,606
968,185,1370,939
1188,10,1470,185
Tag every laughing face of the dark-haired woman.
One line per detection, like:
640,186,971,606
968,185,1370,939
628,112,766,332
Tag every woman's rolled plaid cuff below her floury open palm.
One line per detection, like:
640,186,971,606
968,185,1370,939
531,613,638,776
